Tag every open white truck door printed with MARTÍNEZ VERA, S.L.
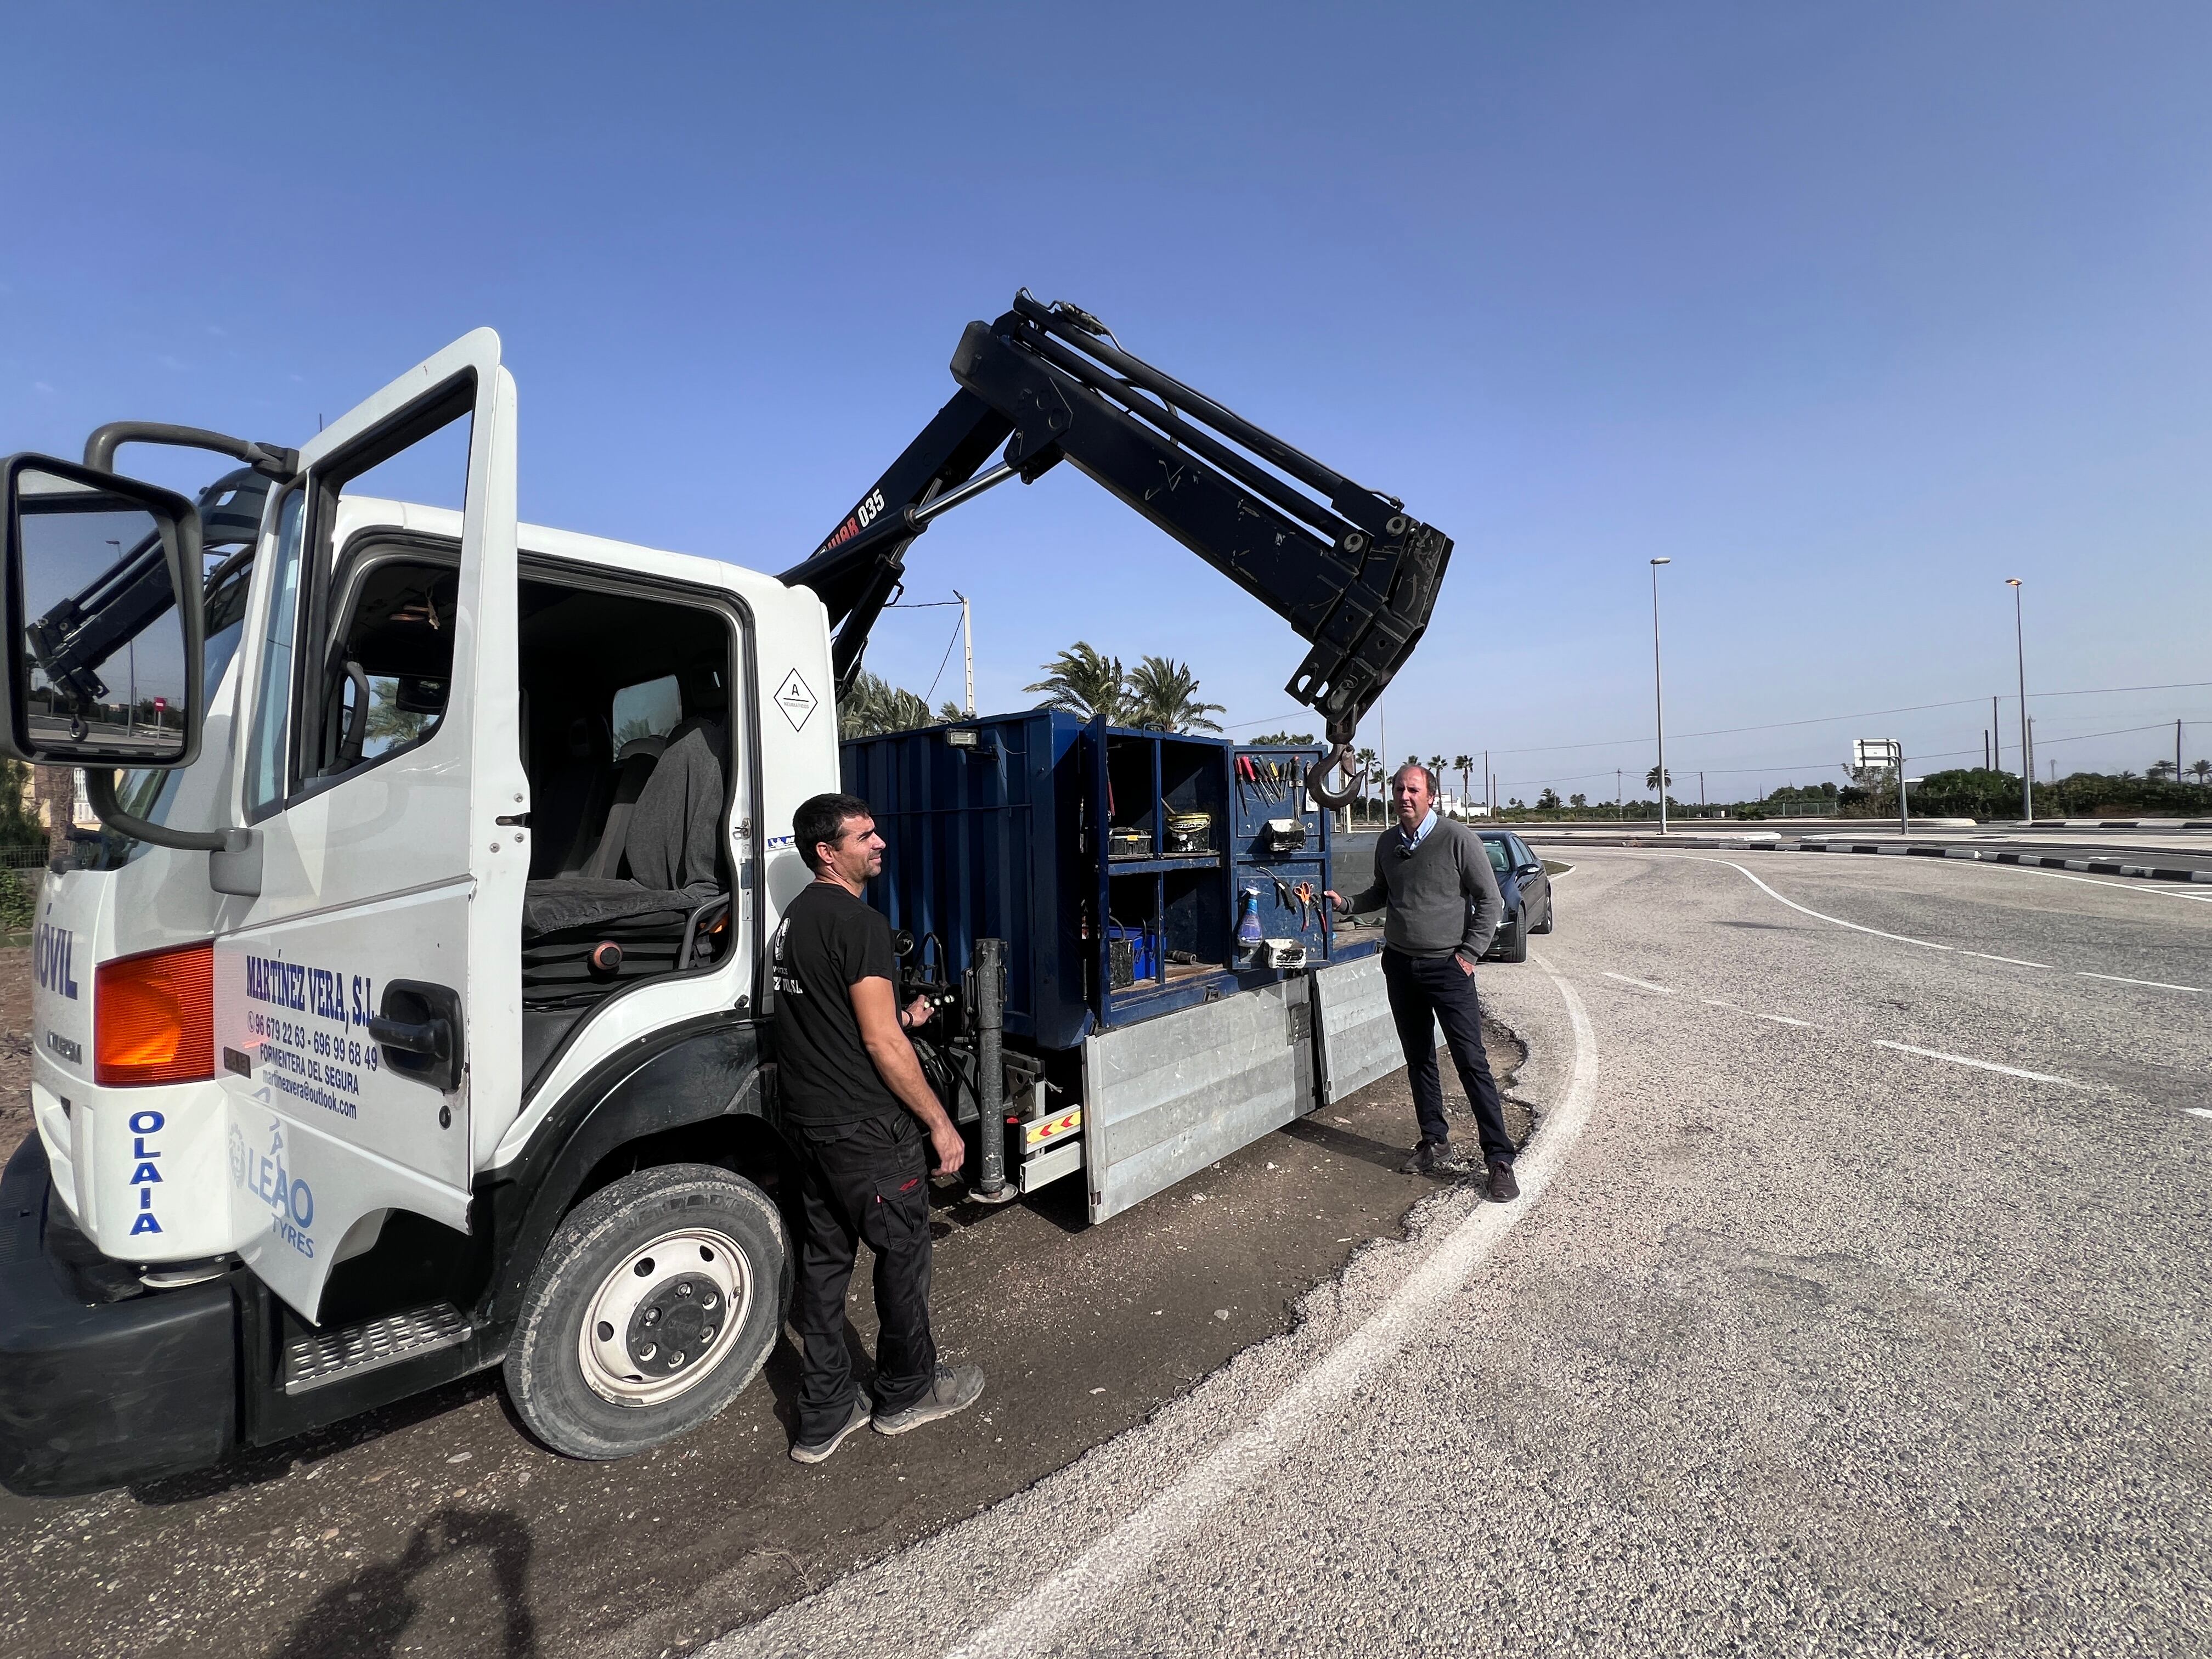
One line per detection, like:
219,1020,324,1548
212,330,531,1321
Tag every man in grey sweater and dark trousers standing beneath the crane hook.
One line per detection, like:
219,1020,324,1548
1329,763,1520,1203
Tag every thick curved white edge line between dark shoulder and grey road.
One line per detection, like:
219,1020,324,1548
947,953,1597,1659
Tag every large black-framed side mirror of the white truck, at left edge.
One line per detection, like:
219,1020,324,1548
0,456,204,770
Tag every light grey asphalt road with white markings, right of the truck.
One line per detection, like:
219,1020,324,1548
712,849,2212,1659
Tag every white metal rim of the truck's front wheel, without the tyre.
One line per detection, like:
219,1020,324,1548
575,1228,752,1407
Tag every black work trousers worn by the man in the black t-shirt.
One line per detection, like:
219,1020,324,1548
789,1113,938,1444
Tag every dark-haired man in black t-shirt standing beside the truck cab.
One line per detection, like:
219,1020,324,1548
772,794,982,1462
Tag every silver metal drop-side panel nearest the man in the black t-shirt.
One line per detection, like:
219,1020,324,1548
1084,980,1307,1221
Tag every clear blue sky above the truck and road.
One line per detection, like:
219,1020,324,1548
0,4,2212,797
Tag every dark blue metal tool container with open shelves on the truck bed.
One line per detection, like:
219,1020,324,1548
843,710,1329,1051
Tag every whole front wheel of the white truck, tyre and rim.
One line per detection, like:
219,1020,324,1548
506,1164,792,1460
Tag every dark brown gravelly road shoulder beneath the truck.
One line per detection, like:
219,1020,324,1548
0,982,1526,1659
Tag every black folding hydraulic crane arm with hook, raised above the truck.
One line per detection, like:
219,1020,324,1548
783,290,1451,805
